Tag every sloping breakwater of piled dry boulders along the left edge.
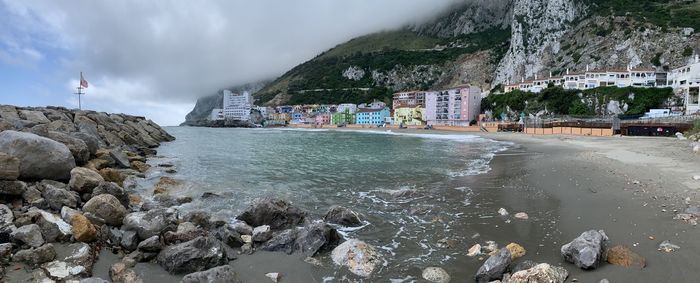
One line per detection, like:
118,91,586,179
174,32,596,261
0,105,174,282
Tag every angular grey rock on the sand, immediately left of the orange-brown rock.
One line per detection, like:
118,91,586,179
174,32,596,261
561,230,608,269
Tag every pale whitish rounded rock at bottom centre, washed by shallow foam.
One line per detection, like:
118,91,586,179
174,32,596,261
331,239,382,277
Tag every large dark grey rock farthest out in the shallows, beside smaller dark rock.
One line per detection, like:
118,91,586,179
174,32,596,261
237,198,306,230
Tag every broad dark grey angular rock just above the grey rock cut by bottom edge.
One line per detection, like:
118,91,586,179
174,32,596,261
157,237,228,274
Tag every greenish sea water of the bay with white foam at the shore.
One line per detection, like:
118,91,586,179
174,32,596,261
139,127,509,281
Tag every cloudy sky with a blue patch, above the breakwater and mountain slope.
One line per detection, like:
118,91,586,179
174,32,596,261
0,0,460,126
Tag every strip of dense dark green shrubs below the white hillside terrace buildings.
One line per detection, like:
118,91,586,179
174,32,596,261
481,87,673,116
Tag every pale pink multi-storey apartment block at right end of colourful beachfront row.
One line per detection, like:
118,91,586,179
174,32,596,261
425,85,481,126
